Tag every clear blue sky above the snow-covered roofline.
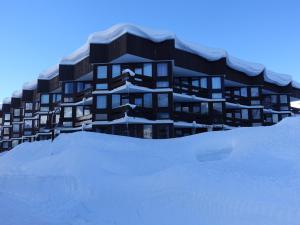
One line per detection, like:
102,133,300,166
0,0,300,102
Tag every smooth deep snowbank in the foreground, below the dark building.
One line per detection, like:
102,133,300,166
0,117,300,225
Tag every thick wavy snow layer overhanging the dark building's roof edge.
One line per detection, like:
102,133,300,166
56,24,300,88
